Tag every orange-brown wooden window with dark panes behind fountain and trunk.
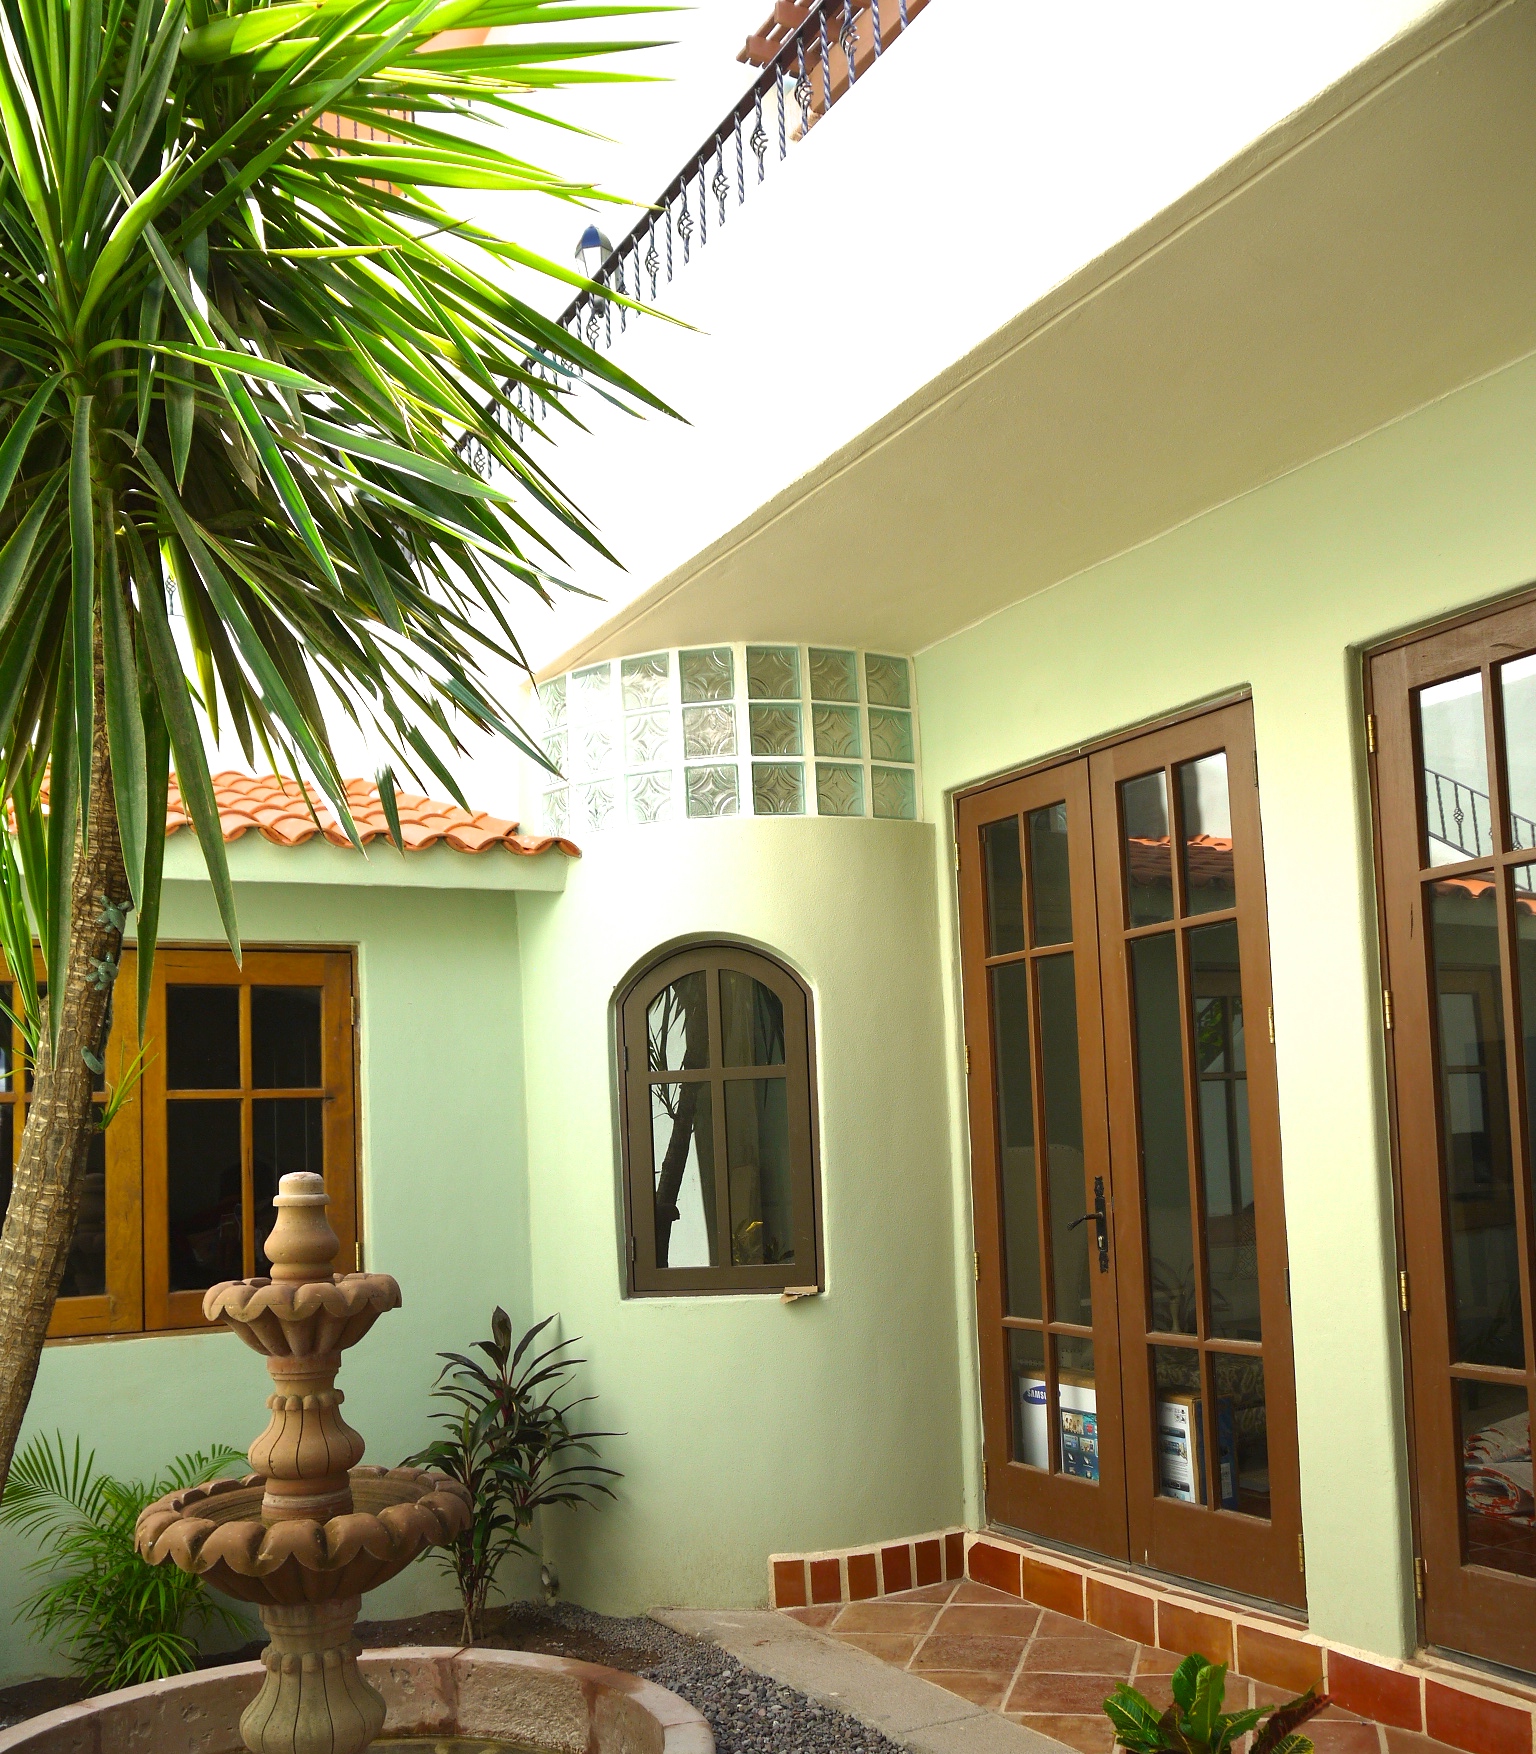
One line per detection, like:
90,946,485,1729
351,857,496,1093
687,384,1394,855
0,945,358,1338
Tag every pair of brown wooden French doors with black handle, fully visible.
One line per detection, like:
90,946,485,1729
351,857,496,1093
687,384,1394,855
957,702,1305,1605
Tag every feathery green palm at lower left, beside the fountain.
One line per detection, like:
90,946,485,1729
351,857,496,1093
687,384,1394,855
0,1433,247,1693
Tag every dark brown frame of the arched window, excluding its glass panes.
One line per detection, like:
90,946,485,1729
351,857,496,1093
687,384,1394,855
615,940,824,1298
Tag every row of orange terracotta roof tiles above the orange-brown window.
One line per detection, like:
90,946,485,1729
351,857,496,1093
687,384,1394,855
154,774,580,858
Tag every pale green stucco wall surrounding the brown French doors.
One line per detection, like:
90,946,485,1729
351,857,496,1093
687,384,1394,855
917,349,1536,1654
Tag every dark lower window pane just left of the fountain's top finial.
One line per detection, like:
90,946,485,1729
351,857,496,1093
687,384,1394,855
165,1101,245,1291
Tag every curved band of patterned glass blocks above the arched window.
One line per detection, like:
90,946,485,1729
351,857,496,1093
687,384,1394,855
537,645,921,835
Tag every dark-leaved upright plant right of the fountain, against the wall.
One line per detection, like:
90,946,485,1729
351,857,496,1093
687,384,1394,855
410,1307,621,1643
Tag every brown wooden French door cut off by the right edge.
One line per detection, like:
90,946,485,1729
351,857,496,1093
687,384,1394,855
1369,602,1536,1670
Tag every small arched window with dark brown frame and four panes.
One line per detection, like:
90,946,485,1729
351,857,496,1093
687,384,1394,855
619,944,821,1293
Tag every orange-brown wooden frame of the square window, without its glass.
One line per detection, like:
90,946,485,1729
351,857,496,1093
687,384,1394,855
0,944,361,1340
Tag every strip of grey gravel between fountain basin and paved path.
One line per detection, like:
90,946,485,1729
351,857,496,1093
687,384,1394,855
547,1601,903,1754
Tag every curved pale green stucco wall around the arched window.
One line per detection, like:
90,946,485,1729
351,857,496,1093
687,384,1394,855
519,819,963,1612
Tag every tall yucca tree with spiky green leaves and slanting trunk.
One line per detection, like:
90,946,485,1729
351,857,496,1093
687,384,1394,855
0,0,659,1482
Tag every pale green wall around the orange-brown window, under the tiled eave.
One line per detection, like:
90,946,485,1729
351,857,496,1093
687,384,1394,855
0,884,530,1684
